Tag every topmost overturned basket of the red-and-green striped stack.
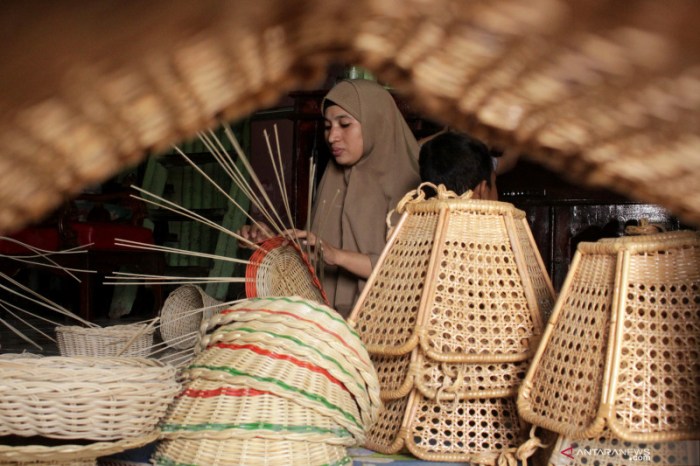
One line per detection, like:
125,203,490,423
200,297,373,373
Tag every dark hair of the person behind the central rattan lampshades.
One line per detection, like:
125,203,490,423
418,132,493,195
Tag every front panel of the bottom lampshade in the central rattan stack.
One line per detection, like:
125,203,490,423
405,393,526,464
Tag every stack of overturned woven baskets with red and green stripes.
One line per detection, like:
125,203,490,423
154,297,381,466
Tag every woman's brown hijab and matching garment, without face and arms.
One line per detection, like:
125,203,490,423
312,80,420,316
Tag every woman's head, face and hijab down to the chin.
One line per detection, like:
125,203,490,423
322,79,415,167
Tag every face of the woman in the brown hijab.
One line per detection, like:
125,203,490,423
324,105,364,167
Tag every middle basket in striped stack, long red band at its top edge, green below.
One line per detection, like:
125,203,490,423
184,343,365,436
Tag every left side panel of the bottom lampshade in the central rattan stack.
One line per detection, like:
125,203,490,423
365,397,409,455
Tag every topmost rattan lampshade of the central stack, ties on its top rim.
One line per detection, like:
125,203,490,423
348,187,554,363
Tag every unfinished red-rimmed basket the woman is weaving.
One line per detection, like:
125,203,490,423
245,236,328,305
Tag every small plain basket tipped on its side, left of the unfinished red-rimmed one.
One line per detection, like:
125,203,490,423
160,285,225,349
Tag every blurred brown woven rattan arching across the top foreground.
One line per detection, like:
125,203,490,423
0,0,700,233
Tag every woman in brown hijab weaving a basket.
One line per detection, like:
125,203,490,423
241,80,419,316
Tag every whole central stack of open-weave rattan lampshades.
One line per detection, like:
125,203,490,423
349,186,554,464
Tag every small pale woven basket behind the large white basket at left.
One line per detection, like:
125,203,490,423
56,324,155,357
